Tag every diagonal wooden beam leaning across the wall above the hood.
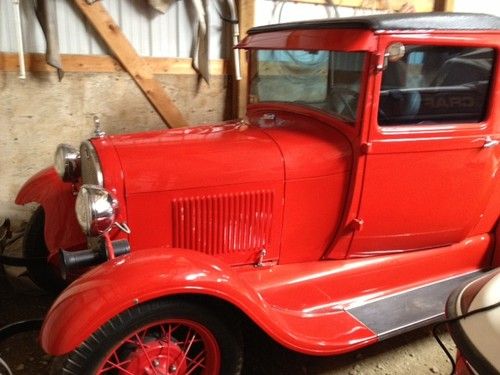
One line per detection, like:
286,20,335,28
74,0,187,128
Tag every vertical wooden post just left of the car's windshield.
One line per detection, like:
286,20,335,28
235,0,255,117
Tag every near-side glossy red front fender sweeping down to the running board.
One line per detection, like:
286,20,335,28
41,248,377,355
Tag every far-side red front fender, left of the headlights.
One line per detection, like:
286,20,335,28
16,167,86,254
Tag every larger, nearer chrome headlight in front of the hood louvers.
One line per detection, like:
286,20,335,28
75,185,118,237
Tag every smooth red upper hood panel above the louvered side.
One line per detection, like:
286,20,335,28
105,122,284,194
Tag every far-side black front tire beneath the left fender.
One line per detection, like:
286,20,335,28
22,206,66,294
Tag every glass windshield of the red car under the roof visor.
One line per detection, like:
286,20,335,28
249,50,365,122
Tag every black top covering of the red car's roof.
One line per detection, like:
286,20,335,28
248,12,500,34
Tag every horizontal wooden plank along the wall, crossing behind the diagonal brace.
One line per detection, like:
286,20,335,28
0,52,228,76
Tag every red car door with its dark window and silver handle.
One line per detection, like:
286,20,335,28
348,33,500,257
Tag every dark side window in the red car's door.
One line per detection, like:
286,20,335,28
378,45,495,126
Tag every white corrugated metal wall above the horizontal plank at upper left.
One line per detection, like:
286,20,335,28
0,0,227,59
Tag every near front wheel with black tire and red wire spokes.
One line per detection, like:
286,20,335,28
53,300,243,375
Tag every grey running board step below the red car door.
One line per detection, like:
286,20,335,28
346,271,485,340
